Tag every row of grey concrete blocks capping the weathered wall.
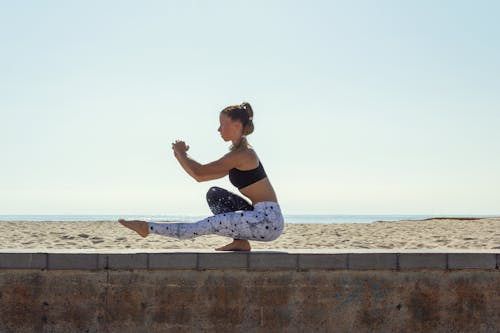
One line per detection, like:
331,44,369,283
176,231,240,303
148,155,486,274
0,250,500,270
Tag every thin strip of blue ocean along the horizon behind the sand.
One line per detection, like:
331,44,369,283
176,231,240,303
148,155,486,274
0,214,493,224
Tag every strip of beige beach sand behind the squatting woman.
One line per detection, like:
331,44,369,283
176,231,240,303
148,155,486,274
0,217,500,250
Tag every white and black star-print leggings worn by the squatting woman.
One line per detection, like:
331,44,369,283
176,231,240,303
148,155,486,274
148,187,284,242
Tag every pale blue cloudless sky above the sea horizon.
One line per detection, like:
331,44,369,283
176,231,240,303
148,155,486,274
0,0,500,215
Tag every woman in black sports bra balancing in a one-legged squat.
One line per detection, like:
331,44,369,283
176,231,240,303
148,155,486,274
119,102,284,251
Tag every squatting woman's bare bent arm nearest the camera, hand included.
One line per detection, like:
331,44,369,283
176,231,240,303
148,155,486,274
172,141,237,182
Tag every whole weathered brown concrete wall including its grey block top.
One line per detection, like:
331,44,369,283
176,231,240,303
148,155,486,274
0,251,500,332
